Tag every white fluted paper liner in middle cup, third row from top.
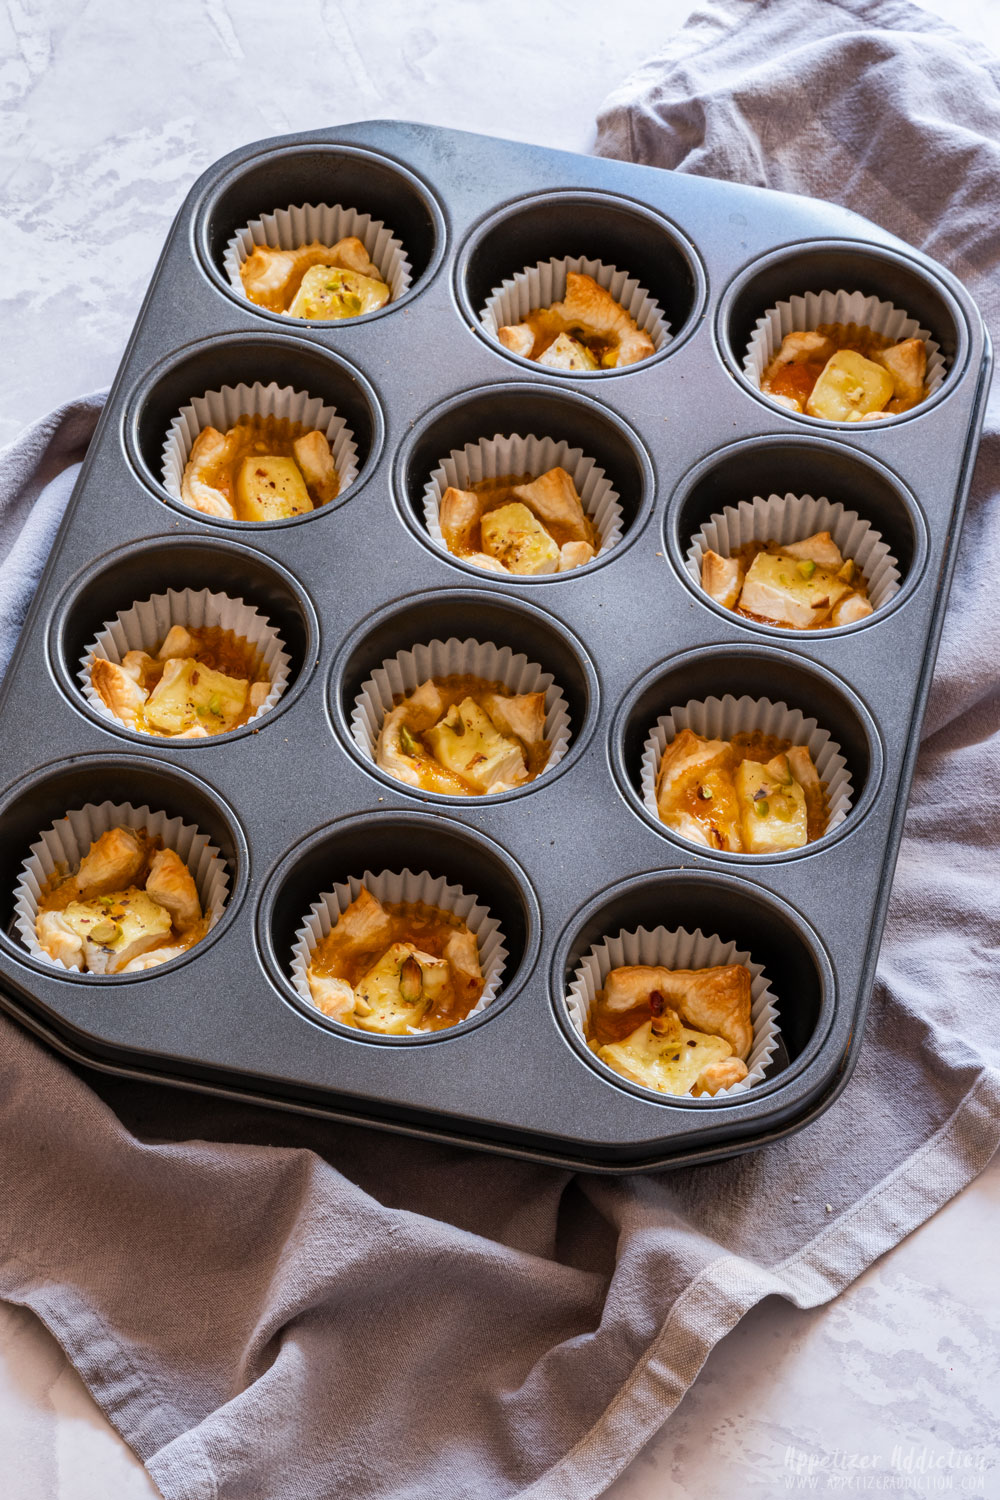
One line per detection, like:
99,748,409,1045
351,636,570,797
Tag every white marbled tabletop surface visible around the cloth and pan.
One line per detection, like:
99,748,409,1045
0,0,1000,1500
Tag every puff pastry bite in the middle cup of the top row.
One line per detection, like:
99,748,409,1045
496,272,655,371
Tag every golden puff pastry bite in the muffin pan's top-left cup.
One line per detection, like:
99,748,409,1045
240,234,390,321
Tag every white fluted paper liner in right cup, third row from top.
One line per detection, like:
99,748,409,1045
640,693,853,860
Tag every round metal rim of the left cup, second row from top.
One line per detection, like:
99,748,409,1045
120,329,387,536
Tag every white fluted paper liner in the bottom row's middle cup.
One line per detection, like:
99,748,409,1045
291,870,507,1025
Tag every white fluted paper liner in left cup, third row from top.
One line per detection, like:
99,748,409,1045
76,588,291,740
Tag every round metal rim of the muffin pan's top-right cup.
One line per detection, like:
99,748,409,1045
712,237,972,435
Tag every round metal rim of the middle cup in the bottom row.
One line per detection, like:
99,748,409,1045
253,807,541,1047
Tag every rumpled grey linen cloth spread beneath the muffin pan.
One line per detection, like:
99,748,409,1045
0,0,1000,1500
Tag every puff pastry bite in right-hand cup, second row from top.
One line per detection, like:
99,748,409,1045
702,531,873,630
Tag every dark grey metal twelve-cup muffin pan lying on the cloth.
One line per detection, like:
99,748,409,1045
0,122,990,1173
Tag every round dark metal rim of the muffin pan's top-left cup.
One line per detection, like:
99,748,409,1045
189,141,448,333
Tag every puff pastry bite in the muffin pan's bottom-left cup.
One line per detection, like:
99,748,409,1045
34,828,208,974
